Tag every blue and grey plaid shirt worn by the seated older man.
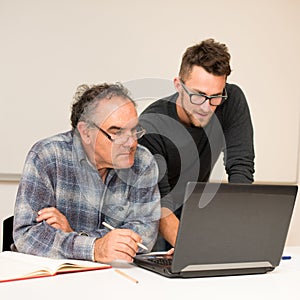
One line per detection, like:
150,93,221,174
14,131,160,260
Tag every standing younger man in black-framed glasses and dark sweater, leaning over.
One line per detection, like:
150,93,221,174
140,39,254,250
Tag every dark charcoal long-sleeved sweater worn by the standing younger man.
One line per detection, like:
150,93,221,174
140,83,254,211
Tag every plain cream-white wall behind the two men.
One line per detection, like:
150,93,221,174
0,0,300,248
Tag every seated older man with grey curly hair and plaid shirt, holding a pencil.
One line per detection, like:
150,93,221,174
14,84,160,263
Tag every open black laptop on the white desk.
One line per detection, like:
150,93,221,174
134,182,298,278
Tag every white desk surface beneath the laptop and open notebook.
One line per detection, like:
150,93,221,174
0,247,300,300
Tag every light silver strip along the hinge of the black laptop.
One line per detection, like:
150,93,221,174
181,261,273,272
